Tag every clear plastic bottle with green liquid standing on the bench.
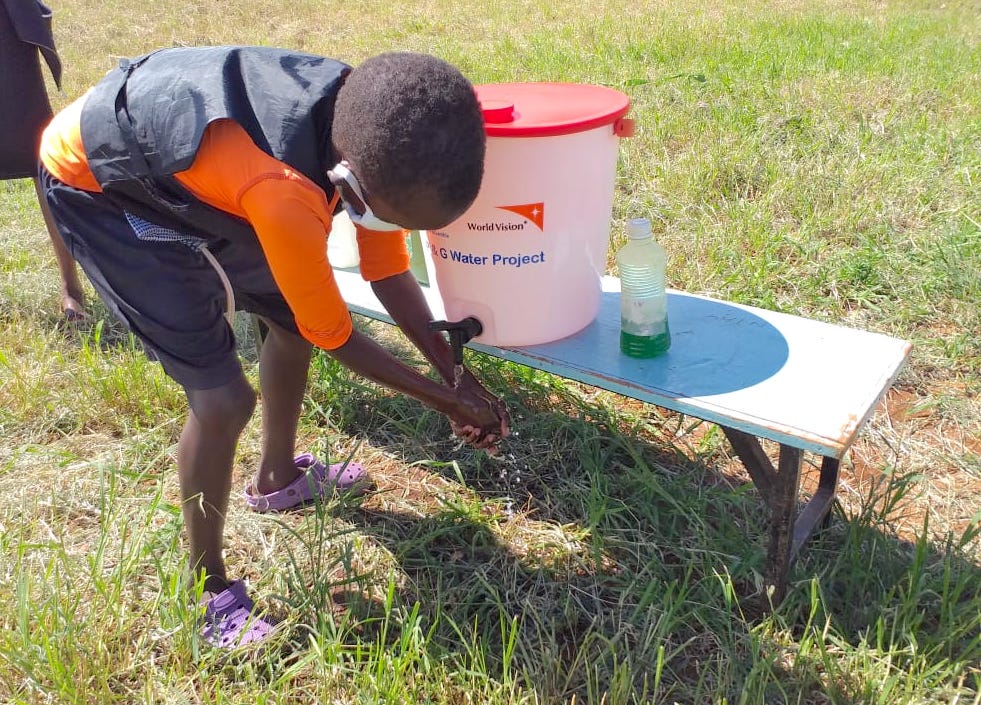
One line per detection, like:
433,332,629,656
617,218,671,357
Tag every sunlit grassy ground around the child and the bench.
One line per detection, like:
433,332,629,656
0,0,981,705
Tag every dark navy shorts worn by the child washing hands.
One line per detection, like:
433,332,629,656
40,166,299,389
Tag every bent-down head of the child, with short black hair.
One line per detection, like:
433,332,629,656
332,52,486,229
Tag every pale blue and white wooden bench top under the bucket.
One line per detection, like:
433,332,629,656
335,270,910,458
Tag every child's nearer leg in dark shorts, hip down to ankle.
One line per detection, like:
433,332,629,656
40,169,255,591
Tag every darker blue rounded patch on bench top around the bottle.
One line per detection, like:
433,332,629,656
512,292,791,398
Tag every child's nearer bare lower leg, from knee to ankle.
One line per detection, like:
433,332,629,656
177,374,255,592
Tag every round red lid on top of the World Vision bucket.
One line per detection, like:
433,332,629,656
475,83,630,137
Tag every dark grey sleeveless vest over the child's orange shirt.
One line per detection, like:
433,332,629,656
81,47,350,238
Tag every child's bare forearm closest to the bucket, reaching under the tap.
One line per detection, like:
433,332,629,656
371,272,453,384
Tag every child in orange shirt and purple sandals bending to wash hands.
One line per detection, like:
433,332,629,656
39,46,508,647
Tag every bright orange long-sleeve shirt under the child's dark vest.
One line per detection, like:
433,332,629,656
41,96,409,350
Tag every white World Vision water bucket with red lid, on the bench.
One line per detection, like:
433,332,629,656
427,83,632,346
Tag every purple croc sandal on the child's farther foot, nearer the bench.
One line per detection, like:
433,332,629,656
245,453,369,512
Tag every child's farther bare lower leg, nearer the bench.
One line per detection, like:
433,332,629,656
253,319,312,494
